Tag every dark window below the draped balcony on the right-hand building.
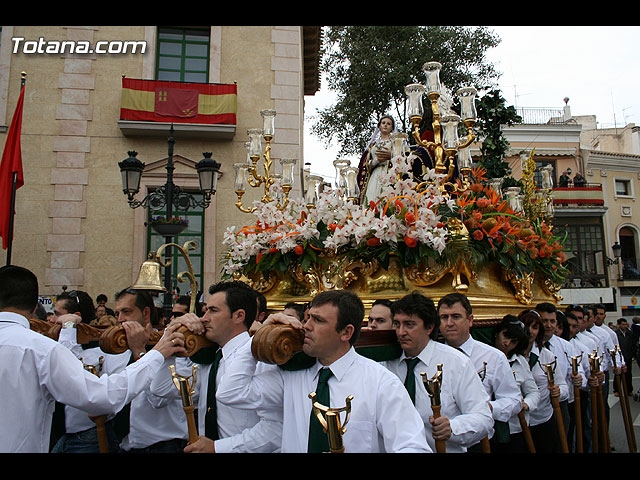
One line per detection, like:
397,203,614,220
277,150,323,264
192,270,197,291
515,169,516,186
560,224,609,288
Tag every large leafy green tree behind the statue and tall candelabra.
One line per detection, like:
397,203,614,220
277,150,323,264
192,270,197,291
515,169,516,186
311,25,499,155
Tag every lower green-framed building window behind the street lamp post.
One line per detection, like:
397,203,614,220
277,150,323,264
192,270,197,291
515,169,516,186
147,192,204,295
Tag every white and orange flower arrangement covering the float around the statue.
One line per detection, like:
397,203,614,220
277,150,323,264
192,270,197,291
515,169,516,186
223,152,568,290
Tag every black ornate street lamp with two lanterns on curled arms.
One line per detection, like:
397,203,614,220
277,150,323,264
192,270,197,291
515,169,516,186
118,124,220,315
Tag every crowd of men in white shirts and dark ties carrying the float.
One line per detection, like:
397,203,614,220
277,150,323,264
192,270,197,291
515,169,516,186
0,266,640,453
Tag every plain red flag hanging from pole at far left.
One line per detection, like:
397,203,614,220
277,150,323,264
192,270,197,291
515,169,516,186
0,85,24,249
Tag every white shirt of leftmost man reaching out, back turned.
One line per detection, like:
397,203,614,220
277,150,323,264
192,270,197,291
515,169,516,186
0,312,164,453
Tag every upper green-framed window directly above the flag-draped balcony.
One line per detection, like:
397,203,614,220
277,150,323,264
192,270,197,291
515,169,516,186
156,27,209,83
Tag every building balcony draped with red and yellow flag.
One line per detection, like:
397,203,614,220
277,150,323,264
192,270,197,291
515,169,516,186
118,77,238,140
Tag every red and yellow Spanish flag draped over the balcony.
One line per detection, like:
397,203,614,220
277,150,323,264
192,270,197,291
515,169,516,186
120,78,238,125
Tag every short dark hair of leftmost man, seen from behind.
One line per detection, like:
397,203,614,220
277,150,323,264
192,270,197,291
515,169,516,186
0,265,38,312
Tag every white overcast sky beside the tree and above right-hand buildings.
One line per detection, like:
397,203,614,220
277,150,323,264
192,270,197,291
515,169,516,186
304,26,640,181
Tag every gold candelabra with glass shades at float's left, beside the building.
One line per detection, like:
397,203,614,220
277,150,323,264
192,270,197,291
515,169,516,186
233,110,296,213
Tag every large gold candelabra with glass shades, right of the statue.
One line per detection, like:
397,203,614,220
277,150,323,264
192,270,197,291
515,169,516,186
405,62,477,195
